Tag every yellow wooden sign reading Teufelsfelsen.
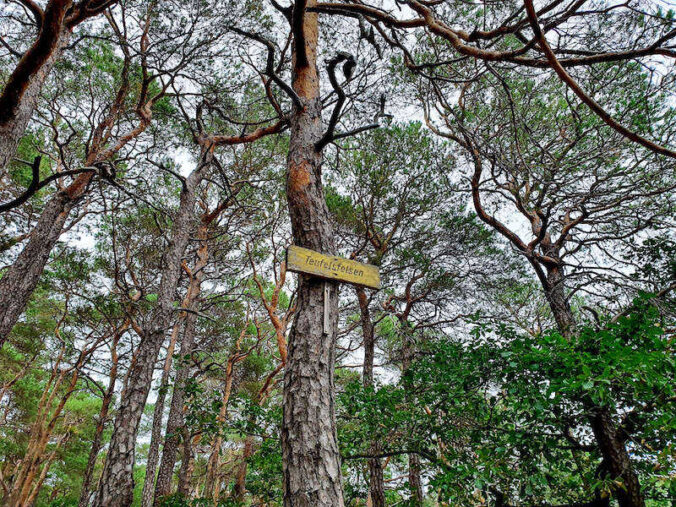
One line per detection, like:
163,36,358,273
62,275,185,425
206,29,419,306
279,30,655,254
286,245,380,289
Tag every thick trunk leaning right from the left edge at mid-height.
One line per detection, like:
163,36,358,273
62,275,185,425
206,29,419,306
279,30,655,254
0,173,93,348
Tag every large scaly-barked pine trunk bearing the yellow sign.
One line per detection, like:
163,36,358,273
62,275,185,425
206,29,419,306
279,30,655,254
282,0,344,507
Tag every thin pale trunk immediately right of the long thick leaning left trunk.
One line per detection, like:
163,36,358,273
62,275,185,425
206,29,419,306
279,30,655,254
141,322,181,507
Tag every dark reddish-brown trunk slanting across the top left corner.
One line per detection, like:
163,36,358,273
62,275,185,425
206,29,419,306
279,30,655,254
0,0,73,171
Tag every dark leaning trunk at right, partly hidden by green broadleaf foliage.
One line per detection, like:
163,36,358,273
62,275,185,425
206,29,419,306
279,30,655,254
545,266,645,507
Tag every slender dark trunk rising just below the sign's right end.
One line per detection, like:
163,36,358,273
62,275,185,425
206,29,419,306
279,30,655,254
356,287,385,507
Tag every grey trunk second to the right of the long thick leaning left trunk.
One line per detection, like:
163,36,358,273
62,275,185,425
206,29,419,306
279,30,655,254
155,300,202,505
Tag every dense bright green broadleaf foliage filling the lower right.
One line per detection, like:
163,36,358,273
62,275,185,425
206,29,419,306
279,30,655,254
340,296,676,505
